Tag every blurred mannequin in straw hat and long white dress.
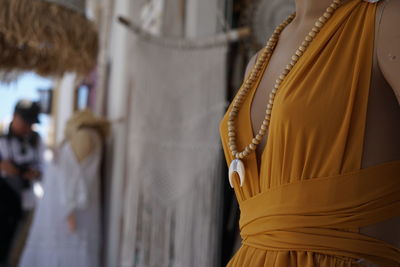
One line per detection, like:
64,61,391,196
19,110,109,267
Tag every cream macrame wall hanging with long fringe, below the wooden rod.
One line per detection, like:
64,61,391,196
121,38,226,267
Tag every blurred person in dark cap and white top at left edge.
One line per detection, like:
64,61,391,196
0,100,43,265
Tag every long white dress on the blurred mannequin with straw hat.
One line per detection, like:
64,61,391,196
19,132,101,267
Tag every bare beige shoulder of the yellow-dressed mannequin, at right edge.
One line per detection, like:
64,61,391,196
377,0,400,103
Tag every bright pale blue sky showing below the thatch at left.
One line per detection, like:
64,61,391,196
0,72,52,139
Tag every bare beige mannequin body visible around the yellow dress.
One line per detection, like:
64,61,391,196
246,0,400,251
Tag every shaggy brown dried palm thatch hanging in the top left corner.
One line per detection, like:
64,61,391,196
0,0,98,76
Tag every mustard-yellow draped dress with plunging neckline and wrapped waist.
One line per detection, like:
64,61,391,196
220,0,400,267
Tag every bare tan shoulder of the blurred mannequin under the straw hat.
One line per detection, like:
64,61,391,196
71,129,95,162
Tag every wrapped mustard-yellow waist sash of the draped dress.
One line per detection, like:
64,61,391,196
240,161,400,266
